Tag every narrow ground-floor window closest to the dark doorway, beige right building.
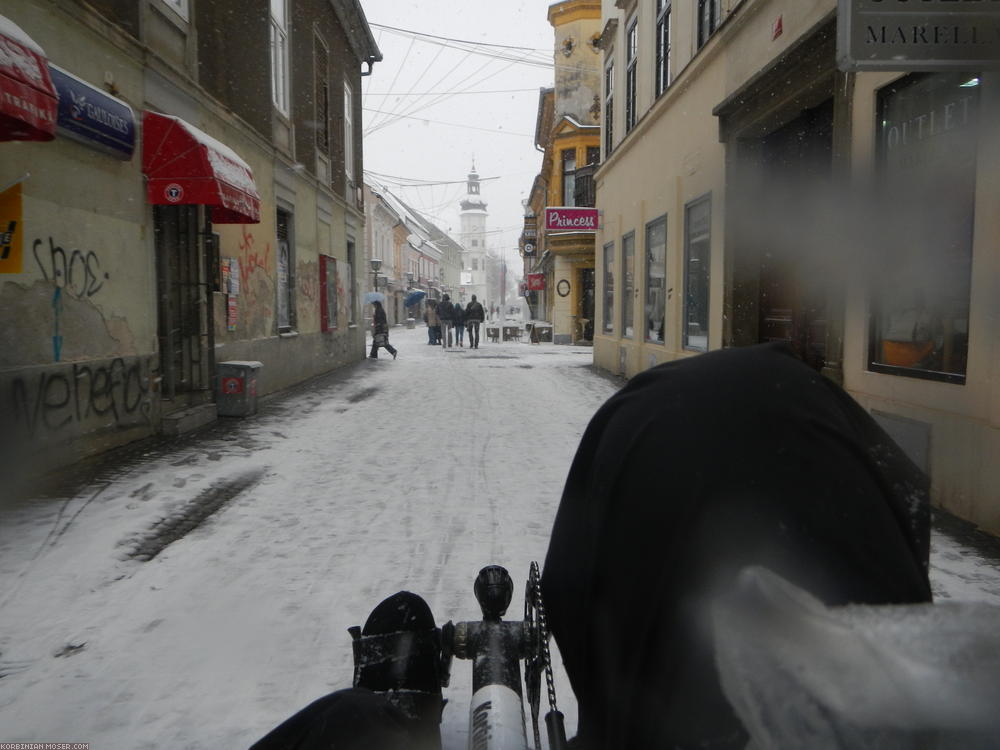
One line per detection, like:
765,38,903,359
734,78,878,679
683,196,712,352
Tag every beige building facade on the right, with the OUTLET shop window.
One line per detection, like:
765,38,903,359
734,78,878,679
594,0,1000,533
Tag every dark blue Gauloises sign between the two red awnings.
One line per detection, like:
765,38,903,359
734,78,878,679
49,64,135,161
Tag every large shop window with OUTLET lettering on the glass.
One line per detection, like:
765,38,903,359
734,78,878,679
869,73,979,383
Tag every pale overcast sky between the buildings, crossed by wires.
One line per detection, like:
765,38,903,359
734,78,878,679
361,0,554,270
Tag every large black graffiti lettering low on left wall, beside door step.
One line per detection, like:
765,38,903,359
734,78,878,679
6,357,152,438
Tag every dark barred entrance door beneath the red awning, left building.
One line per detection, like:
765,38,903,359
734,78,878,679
153,206,213,415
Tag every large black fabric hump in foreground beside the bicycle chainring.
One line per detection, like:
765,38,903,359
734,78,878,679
542,345,931,750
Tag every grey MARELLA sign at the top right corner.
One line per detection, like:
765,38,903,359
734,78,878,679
837,0,1000,72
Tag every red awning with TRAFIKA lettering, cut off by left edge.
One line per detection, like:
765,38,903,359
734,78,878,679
0,16,59,141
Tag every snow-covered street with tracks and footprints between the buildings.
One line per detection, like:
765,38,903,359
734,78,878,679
0,325,1000,750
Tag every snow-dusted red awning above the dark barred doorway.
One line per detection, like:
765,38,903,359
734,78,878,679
142,112,260,224
